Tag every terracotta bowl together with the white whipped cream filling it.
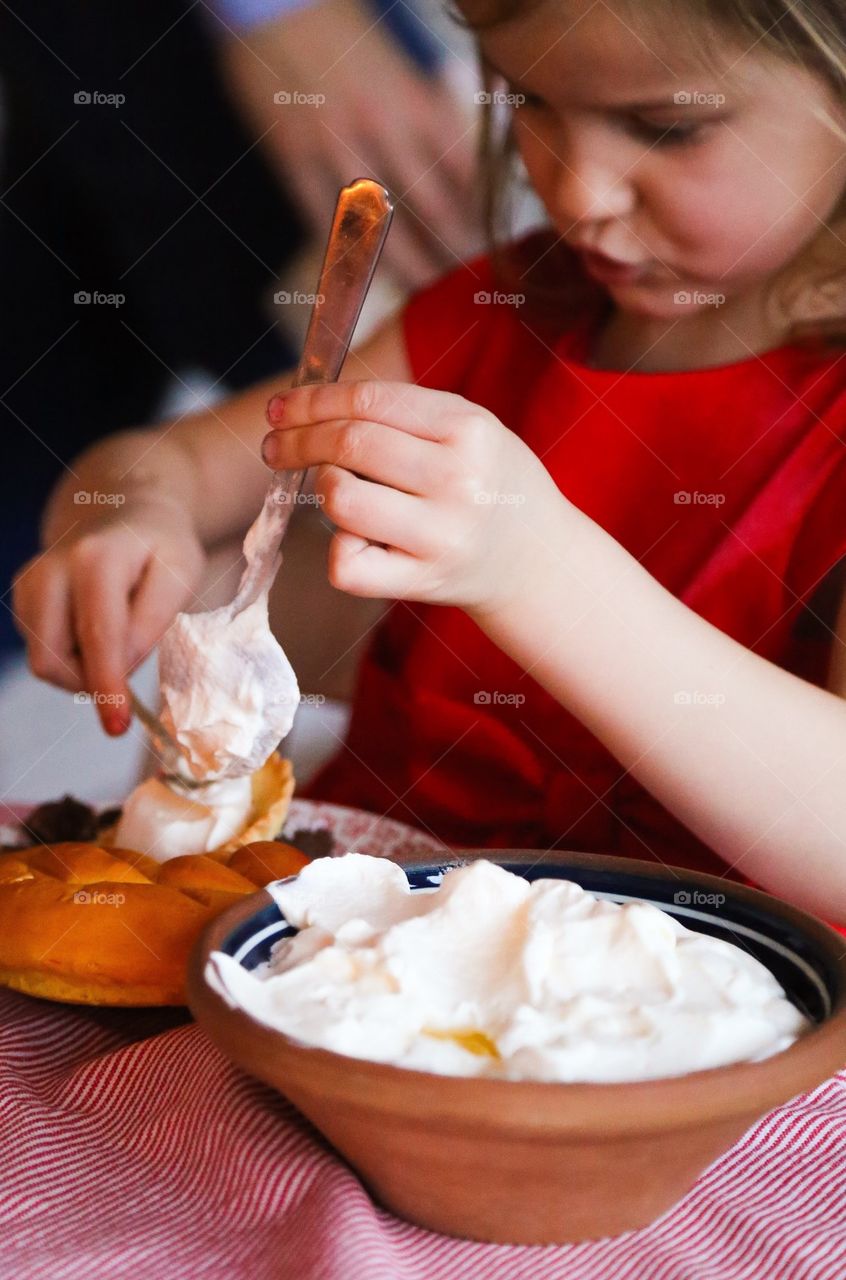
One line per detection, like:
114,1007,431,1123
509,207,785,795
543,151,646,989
188,850,846,1244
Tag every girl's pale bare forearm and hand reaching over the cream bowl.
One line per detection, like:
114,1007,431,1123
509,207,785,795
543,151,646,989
261,383,846,922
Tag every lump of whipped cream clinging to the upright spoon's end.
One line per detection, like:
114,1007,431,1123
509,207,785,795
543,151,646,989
159,591,299,782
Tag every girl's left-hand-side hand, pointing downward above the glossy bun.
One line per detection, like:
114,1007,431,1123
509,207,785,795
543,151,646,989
13,502,205,733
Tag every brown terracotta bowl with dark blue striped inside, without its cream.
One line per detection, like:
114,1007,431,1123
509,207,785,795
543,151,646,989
188,850,846,1244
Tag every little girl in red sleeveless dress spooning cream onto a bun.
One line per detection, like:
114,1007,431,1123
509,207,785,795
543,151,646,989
15,0,846,922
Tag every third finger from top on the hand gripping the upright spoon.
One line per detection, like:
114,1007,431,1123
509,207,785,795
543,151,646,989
315,466,439,556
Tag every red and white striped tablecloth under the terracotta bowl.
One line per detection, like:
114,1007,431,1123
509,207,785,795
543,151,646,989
0,992,846,1280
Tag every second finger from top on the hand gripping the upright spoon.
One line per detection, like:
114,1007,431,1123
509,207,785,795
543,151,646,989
262,420,447,494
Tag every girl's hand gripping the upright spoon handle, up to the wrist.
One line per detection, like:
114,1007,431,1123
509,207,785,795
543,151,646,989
262,381,572,613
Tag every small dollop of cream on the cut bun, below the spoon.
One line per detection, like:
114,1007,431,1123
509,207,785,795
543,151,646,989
114,777,252,863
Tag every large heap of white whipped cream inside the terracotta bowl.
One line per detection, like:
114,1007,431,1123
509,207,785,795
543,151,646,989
206,854,809,1083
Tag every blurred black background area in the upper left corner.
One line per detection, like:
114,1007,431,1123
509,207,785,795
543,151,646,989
0,0,306,644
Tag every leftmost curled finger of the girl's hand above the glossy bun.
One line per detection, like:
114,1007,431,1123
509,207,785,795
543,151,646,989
14,561,84,692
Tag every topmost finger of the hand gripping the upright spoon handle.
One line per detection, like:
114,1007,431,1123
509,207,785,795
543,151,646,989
270,381,470,443
